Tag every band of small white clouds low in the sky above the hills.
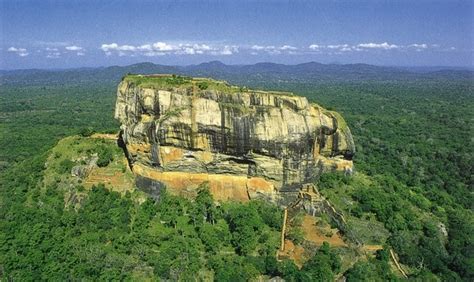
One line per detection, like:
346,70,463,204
7,41,457,59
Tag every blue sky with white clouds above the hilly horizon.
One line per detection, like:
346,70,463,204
0,0,474,69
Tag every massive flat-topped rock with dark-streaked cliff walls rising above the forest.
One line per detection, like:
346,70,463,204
115,75,354,205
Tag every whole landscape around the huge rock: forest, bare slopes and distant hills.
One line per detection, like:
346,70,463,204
0,62,474,281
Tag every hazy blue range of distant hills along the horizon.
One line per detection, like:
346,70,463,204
0,61,474,85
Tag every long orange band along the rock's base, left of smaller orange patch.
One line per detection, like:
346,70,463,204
133,164,254,202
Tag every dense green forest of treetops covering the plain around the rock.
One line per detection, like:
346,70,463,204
0,65,474,281
